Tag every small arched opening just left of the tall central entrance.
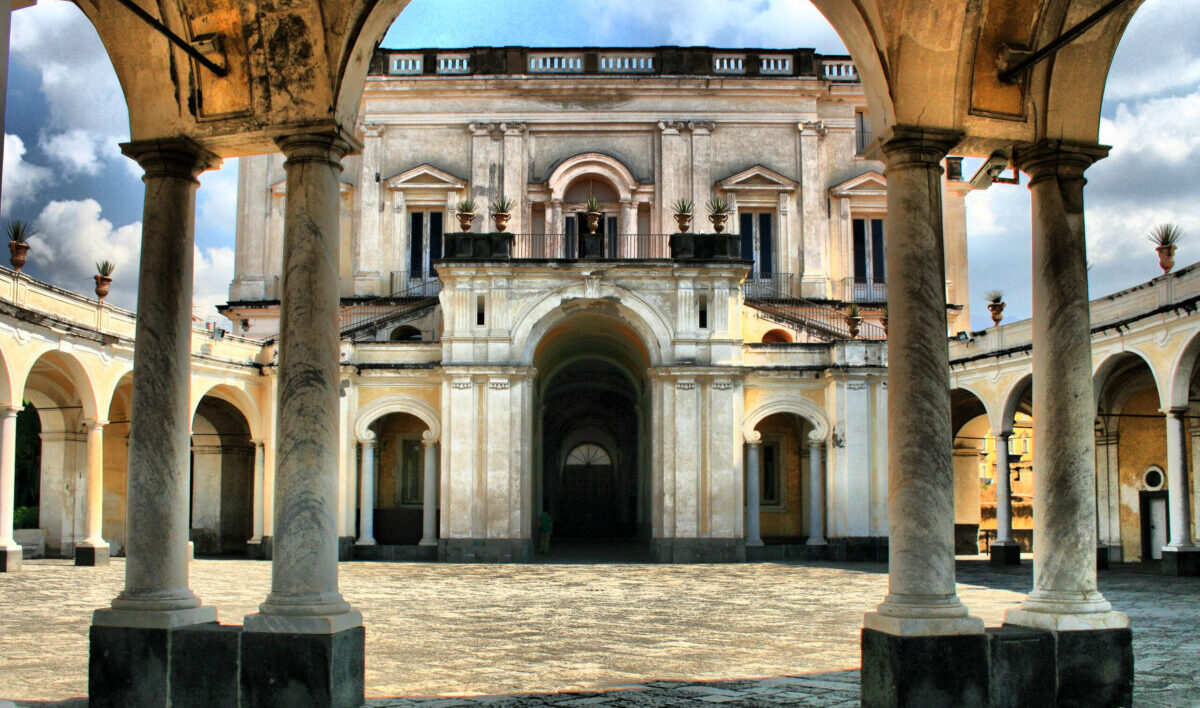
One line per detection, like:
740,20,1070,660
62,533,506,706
359,413,430,546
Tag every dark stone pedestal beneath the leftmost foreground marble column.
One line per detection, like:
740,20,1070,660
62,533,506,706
88,622,241,708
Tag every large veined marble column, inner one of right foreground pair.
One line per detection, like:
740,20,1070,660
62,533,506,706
865,126,983,636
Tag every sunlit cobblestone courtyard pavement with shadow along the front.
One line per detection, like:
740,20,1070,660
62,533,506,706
0,559,1200,708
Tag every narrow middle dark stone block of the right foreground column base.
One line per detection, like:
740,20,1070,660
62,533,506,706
985,626,1055,708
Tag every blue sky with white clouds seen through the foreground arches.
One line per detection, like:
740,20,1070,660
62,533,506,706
0,0,1200,328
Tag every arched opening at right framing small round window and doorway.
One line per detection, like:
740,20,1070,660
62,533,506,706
1096,353,1166,562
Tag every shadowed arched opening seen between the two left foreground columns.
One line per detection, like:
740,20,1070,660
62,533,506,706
190,394,254,556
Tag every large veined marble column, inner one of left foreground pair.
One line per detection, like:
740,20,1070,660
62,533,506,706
244,131,362,635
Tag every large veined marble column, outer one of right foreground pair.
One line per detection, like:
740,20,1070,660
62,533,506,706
1008,142,1128,630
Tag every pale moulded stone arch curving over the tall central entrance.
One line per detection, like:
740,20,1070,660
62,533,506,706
511,282,673,366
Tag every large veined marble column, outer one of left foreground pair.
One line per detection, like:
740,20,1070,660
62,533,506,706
92,138,221,628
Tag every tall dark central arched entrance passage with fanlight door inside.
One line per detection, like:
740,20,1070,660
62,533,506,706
534,311,650,557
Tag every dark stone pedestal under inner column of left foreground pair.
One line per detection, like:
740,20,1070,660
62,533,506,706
241,626,366,708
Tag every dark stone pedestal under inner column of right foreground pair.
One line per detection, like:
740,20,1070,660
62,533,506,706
862,628,988,708
